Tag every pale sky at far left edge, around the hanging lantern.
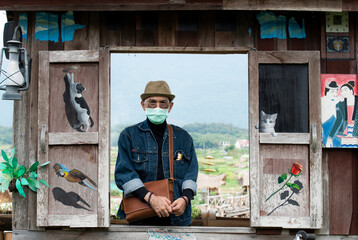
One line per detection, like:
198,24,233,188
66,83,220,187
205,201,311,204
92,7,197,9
0,11,14,127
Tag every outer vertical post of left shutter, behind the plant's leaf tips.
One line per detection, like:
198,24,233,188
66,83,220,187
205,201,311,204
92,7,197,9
37,51,50,226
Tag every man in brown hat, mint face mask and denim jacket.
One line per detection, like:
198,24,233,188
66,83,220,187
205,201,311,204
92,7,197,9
115,81,198,226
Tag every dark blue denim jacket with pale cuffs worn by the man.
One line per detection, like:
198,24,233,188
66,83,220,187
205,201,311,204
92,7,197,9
115,120,198,226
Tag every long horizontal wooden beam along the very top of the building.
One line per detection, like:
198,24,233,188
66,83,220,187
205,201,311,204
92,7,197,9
0,0,344,12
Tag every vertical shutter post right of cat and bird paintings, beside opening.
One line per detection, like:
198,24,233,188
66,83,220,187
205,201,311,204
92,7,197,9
98,50,111,227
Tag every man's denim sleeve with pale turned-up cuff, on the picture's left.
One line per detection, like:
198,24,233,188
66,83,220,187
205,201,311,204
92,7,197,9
114,130,144,197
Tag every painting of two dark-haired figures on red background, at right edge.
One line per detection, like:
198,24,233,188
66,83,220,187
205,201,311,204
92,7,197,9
321,74,358,148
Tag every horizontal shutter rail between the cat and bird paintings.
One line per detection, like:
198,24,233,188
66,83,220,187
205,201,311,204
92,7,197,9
48,132,98,145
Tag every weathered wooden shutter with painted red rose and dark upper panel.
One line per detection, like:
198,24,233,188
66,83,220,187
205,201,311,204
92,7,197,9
249,51,323,228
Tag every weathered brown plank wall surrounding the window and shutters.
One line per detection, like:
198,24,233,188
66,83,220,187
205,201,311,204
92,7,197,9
5,9,358,235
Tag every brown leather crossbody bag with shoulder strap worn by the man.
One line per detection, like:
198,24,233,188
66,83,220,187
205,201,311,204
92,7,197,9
122,124,174,222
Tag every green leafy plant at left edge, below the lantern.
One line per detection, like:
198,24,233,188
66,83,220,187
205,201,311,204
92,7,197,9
0,148,50,198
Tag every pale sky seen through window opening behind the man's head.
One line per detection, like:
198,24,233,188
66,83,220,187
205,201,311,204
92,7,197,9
111,53,248,129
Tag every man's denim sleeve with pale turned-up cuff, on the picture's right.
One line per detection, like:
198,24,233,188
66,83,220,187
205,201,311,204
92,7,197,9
182,137,199,196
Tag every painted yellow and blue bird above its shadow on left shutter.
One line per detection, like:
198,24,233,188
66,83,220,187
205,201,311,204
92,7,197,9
53,163,97,191
